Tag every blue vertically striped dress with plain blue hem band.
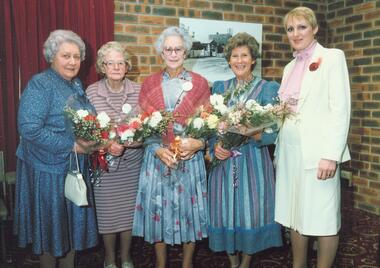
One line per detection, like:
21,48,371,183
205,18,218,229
208,78,282,254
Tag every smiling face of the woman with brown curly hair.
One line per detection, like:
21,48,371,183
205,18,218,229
228,46,255,80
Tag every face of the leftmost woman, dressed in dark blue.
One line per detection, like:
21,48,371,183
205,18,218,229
51,43,81,81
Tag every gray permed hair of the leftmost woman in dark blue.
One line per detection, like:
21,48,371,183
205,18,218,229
43,30,86,63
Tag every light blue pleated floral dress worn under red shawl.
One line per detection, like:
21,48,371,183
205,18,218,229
132,71,208,245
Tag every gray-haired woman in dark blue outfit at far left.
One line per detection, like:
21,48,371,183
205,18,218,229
14,30,97,268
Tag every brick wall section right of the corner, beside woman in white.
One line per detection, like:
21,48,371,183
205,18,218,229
326,0,380,214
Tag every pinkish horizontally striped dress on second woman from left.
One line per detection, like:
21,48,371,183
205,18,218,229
86,79,143,234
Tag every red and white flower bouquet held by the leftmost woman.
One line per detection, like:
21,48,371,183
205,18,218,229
65,107,111,145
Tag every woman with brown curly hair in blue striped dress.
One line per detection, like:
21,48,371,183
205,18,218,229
208,33,282,267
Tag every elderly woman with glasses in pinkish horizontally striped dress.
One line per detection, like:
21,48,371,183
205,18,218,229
86,42,143,268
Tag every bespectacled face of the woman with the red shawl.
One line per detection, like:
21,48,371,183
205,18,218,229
162,36,185,71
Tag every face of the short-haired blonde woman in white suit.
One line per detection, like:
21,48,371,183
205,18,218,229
286,16,318,51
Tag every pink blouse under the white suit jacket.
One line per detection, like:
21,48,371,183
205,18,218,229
279,40,317,112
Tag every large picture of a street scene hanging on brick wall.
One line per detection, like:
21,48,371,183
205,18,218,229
179,18,262,84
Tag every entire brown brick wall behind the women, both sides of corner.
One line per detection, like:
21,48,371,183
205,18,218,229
115,0,380,214
